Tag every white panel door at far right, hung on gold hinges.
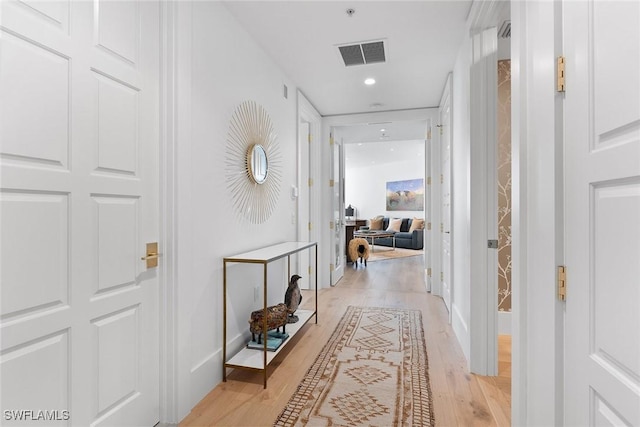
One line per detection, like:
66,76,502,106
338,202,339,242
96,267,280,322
563,0,640,426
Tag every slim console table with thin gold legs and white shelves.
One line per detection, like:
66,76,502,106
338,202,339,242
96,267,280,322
222,242,318,388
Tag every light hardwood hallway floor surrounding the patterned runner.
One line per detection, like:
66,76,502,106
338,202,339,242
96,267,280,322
180,256,511,427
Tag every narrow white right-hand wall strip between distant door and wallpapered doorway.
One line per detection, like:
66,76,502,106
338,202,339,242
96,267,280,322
451,33,471,361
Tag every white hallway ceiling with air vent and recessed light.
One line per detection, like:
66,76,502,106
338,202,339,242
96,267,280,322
224,0,471,116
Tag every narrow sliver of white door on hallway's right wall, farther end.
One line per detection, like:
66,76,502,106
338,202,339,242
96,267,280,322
439,86,453,321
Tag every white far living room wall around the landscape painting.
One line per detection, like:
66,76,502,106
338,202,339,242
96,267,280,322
345,145,428,219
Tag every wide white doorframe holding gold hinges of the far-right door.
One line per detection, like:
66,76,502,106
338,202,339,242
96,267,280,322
511,1,564,425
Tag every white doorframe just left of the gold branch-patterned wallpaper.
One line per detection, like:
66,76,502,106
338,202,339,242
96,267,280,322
469,1,505,375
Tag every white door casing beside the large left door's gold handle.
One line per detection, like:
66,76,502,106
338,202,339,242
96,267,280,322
158,2,192,424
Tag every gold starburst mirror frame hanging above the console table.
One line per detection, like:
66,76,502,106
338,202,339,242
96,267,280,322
225,101,282,224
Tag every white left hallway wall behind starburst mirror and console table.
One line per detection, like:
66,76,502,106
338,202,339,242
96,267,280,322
174,2,297,421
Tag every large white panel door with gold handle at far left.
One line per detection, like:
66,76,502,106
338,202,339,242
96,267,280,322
0,0,159,426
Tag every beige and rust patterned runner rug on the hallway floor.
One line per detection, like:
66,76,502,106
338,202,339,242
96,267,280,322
274,306,434,427
